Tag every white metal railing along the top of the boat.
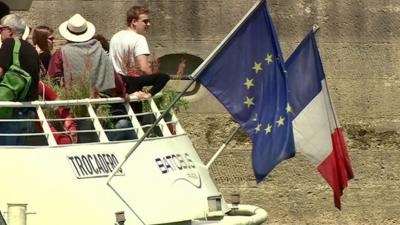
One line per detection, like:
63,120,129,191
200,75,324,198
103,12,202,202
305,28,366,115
0,94,184,146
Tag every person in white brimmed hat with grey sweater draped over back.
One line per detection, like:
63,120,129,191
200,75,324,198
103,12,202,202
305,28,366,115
48,14,115,93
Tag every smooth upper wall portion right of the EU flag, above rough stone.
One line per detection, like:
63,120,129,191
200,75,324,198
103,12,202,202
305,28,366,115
270,0,400,130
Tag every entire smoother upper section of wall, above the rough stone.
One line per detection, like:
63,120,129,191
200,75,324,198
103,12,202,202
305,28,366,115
14,0,400,129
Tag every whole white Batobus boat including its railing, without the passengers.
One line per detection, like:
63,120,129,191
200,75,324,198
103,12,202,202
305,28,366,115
0,95,268,225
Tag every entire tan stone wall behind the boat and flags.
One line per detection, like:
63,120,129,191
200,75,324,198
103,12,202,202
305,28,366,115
12,0,400,224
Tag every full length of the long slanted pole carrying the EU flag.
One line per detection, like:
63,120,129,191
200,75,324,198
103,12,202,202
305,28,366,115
107,0,265,186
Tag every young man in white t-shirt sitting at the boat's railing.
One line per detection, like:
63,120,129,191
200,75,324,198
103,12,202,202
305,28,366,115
110,6,169,112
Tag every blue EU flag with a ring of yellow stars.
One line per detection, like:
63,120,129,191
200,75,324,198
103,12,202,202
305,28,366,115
197,1,295,182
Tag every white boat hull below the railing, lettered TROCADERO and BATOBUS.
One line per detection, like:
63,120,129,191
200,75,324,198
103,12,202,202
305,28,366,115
0,135,227,225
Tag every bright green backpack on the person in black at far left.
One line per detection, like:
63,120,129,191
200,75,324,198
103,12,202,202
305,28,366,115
0,39,32,118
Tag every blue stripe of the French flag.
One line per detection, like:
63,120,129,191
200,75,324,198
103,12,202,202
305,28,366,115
286,31,325,118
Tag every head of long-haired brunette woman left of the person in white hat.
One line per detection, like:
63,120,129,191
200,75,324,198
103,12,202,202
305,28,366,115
32,26,54,71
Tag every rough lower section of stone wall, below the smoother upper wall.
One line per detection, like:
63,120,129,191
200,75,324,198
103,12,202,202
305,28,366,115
178,113,400,225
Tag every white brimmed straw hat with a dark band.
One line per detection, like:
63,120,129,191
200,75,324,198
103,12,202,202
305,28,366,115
58,14,96,42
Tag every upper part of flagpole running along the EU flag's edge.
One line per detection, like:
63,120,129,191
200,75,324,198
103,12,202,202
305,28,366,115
190,0,265,80
